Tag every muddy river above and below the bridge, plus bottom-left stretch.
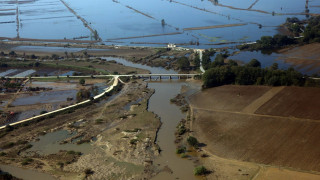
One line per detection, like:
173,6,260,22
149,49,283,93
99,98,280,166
0,58,199,180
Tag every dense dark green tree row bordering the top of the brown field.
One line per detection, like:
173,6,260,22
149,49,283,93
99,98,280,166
202,59,316,88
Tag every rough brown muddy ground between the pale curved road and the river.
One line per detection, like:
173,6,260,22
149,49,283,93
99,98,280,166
0,80,160,179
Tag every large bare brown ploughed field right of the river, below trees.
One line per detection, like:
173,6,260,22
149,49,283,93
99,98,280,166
191,85,320,179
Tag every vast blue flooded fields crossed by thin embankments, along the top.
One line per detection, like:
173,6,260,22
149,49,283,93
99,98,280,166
0,0,320,48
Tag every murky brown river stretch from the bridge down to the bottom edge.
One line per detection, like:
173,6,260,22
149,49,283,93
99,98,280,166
148,80,195,180
